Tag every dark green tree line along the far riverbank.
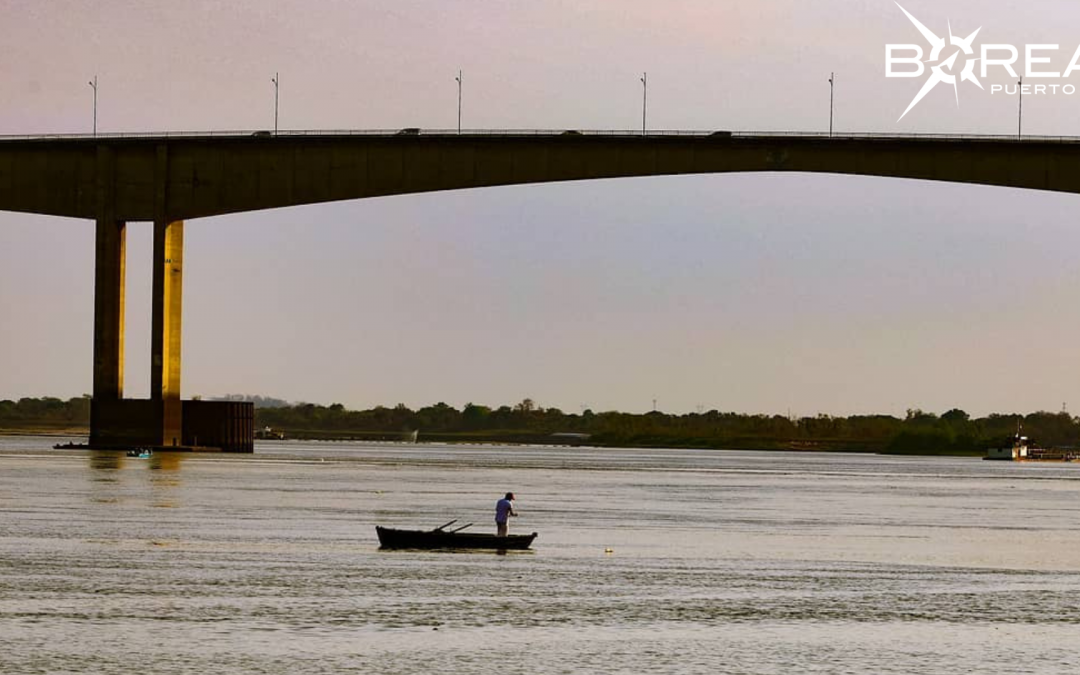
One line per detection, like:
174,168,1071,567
0,396,1080,455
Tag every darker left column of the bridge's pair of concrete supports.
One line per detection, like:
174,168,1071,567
94,218,127,401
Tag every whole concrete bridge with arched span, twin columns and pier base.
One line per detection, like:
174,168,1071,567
0,129,1080,451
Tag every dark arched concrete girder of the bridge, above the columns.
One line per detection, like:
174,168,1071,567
0,134,1080,220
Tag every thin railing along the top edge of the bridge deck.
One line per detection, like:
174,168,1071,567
0,127,1080,144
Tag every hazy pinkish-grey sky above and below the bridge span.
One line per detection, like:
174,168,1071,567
0,0,1080,415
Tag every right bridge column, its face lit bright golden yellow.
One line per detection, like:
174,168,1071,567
150,219,184,445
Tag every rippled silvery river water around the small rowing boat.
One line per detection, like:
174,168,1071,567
0,437,1080,675
